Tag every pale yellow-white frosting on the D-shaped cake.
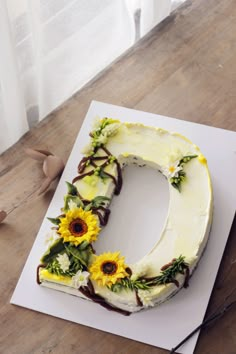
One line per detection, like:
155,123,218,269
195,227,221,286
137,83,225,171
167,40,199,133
41,123,213,312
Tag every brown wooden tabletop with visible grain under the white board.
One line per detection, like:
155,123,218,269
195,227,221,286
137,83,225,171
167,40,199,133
0,0,236,354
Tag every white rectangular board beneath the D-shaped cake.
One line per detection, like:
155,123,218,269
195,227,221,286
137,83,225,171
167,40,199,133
11,102,236,354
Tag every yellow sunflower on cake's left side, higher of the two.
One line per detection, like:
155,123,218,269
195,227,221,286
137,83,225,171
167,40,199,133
58,208,100,246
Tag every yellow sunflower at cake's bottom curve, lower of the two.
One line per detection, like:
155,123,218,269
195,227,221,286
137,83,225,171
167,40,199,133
89,252,128,287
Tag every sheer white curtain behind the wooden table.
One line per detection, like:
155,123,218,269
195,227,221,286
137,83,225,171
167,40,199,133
0,0,183,153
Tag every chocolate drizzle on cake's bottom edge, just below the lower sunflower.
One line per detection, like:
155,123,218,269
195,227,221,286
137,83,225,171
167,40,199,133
78,280,131,316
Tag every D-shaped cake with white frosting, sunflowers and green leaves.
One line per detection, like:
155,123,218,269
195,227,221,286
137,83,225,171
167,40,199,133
37,118,213,315
